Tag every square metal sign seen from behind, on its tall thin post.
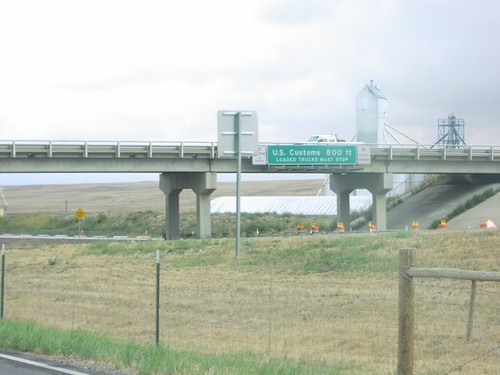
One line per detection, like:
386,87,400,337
217,111,259,258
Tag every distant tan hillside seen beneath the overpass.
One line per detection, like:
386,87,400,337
3,180,323,214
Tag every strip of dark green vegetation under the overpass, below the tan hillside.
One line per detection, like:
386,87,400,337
0,211,348,238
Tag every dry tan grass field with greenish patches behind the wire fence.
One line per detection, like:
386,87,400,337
0,230,500,374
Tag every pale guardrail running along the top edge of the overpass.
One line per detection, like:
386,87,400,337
0,140,500,161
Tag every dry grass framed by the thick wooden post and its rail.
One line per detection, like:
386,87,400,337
415,279,500,374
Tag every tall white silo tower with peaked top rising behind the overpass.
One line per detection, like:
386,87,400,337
356,82,388,144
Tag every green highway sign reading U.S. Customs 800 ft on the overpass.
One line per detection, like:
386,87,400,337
267,144,358,165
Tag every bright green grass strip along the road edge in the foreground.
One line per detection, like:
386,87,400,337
0,320,352,375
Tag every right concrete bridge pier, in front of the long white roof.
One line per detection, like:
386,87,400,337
330,173,393,230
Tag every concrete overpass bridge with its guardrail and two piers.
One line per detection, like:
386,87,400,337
0,141,500,239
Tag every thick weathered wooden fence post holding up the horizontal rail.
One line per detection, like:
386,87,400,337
397,249,416,375
